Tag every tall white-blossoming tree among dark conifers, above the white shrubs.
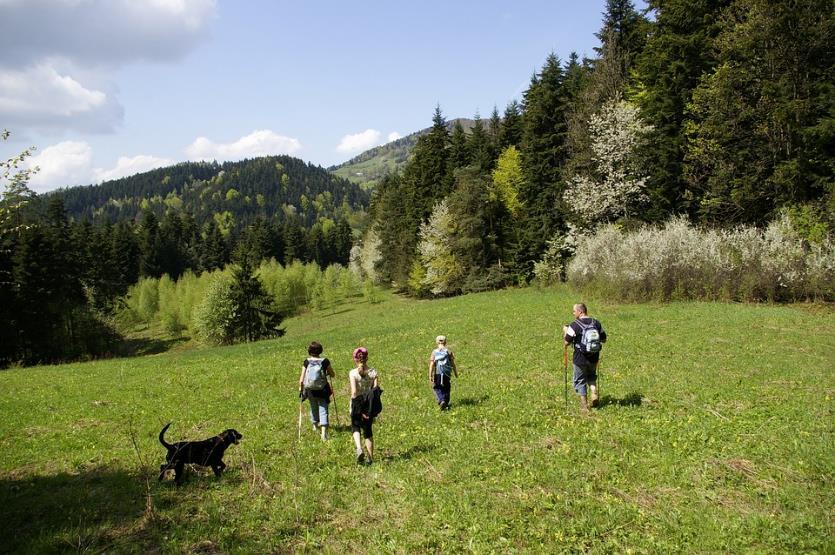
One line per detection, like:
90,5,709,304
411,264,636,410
563,98,651,229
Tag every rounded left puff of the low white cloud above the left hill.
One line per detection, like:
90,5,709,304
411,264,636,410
27,141,93,193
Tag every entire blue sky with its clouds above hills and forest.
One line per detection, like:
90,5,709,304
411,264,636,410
0,0,632,192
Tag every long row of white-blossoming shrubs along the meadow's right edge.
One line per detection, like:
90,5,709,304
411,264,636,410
567,215,835,301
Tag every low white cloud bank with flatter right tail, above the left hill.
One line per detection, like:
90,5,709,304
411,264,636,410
24,140,176,193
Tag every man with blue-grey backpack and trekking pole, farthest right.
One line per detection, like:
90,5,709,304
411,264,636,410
563,303,606,412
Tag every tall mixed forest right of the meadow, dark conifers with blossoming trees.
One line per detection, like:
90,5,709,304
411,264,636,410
357,0,835,295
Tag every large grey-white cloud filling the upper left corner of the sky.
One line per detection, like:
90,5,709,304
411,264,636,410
0,0,217,132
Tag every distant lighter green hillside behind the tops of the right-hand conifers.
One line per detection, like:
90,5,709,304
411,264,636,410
328,118,475,190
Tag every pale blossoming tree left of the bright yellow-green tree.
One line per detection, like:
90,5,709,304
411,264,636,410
418,199,462,295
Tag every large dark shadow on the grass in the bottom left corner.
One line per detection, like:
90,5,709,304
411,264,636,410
0,469,170,553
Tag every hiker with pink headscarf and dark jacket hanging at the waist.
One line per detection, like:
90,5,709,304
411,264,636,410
348,347,383,464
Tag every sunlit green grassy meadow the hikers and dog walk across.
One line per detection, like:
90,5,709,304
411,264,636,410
0,288,835,553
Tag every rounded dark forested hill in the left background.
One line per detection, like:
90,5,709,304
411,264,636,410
48,156,369,227
